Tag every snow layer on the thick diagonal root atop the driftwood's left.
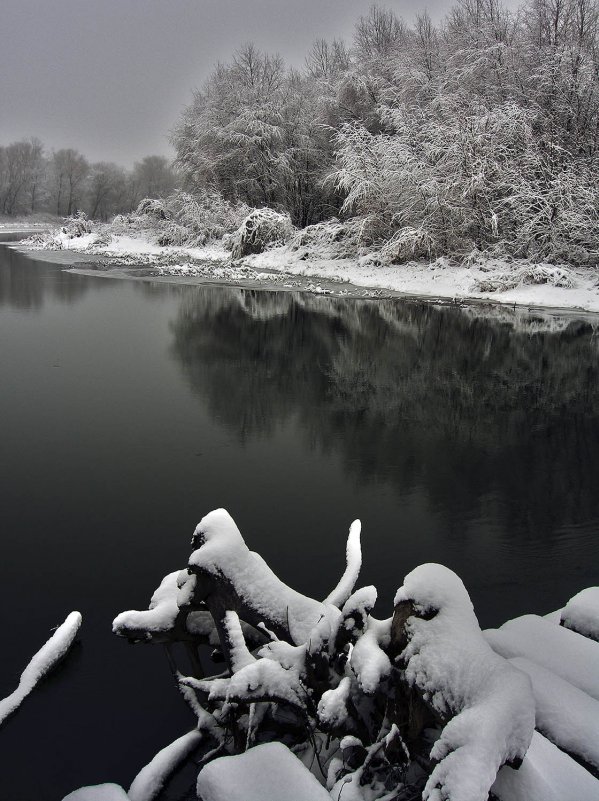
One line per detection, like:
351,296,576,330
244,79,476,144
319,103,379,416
189,509,325,645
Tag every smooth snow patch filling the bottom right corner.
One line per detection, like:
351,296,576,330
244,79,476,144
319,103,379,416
492,732,599,801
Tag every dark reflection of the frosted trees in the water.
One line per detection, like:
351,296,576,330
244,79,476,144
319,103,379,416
172,288,599,542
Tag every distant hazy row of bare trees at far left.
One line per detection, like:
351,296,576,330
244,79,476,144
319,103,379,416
0,138,179,220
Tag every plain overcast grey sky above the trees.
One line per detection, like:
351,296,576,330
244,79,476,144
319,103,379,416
0,0,474,166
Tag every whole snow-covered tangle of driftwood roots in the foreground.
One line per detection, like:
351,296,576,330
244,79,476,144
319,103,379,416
105,509,548,801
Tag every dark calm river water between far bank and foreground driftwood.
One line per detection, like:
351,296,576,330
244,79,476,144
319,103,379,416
0,241,599,801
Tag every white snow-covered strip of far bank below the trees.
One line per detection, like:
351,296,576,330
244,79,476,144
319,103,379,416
12,232,599,313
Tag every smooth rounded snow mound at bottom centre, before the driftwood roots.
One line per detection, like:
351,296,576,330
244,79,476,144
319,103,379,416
197,743,331,801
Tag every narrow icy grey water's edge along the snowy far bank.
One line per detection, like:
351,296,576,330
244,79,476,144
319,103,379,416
7,236,599,324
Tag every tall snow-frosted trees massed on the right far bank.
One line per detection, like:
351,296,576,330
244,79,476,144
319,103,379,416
172,0,599,262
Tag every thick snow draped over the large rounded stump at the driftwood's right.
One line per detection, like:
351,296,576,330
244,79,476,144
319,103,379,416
395,564,535,801
